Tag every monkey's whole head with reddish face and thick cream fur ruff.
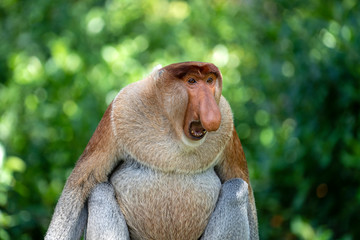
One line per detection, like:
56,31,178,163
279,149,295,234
112,62,234,172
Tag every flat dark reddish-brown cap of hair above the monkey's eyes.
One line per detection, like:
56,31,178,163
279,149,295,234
163,62,221,79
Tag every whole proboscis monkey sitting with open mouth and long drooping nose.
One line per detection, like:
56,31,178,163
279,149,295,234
45,62,258,240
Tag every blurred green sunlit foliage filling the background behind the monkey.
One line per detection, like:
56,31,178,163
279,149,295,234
0,0,360,239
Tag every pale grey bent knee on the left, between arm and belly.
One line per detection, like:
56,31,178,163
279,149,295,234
86,183,130,240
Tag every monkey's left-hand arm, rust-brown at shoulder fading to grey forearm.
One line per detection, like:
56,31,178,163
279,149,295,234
45,104,119,240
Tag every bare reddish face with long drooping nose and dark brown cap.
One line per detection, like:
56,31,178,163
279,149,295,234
163,62,222,140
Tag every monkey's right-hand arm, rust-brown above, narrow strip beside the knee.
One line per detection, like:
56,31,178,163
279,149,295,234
215,127,259,240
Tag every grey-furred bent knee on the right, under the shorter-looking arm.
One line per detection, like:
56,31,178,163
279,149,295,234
201,178,258,240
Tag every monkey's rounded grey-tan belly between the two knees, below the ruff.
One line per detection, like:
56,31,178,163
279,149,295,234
111,164,221,240
